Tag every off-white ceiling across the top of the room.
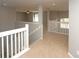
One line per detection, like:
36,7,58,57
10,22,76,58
0,0,69,10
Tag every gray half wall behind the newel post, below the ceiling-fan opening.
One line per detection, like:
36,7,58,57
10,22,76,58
16,21,41,45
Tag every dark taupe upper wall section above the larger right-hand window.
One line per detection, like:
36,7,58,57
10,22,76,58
49,11,69,21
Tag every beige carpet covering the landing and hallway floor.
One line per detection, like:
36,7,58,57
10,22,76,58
20,33,68,58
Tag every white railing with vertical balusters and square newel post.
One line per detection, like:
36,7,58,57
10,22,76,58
0,24,29,58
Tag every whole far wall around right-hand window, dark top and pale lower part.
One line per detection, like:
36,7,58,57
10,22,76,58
48,11,69,34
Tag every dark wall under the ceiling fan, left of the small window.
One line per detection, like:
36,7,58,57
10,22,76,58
16,12,33,22
